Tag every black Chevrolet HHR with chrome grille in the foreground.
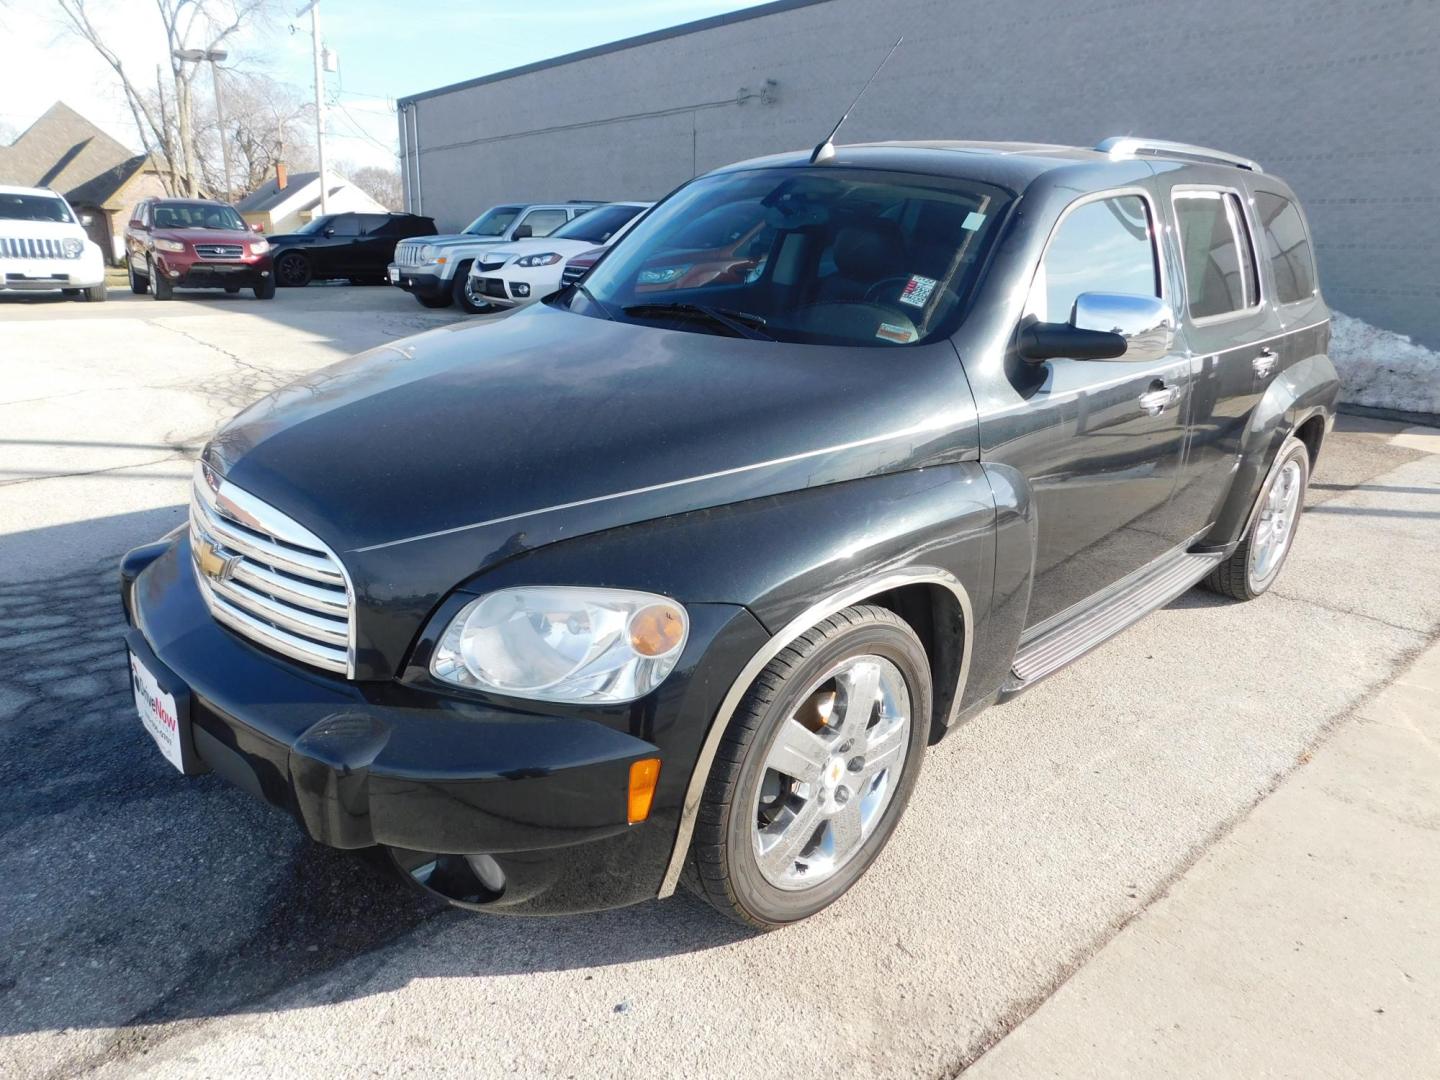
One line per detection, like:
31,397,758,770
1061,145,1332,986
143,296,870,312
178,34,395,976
121,140,1338,927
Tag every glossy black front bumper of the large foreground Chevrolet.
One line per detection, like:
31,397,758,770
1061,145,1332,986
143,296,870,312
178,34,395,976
121,536,759,913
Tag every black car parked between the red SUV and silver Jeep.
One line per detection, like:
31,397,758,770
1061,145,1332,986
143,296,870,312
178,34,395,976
268,213,435,285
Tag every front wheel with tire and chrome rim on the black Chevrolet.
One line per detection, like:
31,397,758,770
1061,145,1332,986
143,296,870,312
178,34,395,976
684,605,933,930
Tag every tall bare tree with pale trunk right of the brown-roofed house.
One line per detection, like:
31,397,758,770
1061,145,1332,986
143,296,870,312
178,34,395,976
55,0,274,194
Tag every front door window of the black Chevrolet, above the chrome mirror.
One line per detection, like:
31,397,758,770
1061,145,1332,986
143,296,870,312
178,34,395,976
1025,194,1159,323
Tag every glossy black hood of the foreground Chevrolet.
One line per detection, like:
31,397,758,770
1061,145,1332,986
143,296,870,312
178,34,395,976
204,305,976,668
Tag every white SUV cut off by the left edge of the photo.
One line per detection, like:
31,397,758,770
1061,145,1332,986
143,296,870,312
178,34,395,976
0,184,105,300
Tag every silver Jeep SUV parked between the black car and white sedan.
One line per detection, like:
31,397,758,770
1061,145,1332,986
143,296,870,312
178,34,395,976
389,202,599,314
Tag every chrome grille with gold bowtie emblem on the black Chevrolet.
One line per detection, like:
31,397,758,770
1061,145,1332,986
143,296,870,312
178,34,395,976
190,462,354,677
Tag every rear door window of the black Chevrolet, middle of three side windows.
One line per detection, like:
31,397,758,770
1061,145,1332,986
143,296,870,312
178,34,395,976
1175,192,1260,318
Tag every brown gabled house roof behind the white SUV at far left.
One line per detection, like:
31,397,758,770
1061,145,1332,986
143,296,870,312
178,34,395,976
0,101,145,206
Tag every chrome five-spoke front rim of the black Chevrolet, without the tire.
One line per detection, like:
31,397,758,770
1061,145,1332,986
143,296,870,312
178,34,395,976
752,655,912,890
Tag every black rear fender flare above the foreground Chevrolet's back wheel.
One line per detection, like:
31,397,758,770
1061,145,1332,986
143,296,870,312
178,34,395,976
1202,353,1339,550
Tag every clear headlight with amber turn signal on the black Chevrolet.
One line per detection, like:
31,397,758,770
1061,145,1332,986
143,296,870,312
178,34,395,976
431,586,690,704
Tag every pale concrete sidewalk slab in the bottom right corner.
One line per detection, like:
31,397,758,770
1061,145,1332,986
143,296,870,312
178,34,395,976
965,639,1440,1080
